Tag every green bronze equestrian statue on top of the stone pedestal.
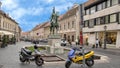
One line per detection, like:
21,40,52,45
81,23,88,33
50,7,59,34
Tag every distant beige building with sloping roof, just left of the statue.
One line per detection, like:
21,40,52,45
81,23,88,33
29,22,49,40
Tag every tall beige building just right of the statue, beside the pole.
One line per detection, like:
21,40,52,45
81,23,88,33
58,4,80,44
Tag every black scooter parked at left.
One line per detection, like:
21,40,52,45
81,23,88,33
19,45,44,66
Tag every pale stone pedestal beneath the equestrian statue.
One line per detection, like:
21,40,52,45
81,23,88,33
47,35,64,54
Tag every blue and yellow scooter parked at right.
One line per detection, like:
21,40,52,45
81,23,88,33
65,48,94,68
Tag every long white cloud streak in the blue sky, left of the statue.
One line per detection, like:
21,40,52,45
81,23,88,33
5,7,43,20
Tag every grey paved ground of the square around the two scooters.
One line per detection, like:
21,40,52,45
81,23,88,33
0,42,120,68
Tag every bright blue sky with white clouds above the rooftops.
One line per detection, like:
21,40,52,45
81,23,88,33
0,0,87,31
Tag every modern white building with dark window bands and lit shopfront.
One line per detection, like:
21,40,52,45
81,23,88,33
83,0,120,48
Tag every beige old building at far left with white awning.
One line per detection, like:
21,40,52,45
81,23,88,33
0,10,21,41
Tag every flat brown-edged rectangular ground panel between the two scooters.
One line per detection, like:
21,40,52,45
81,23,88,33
42,55,65,62
